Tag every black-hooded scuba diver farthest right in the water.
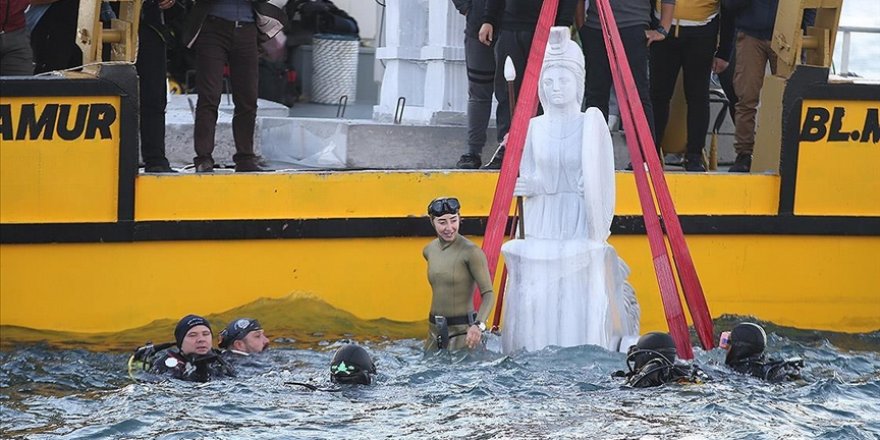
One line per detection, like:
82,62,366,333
718,322,804,382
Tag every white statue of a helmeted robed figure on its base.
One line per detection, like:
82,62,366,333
501,27,639,353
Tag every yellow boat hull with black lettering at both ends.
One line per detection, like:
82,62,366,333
0,66,880,343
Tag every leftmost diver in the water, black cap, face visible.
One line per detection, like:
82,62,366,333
129,315,235,382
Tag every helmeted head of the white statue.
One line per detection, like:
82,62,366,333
538,26,586,111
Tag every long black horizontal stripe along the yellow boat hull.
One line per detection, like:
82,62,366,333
0,215,880,244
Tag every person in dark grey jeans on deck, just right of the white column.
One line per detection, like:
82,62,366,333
452,0,501,169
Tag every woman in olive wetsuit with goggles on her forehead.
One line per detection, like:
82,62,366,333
422,197,495,351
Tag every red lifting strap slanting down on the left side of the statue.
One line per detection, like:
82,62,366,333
474,0,559,310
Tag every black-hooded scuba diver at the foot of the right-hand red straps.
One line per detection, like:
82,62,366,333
611,332,709,388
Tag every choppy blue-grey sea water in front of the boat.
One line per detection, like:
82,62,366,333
0,323,880,439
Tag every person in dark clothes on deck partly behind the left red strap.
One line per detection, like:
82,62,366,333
479,0,577,169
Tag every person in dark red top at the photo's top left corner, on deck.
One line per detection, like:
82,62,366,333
0,0,34,76
